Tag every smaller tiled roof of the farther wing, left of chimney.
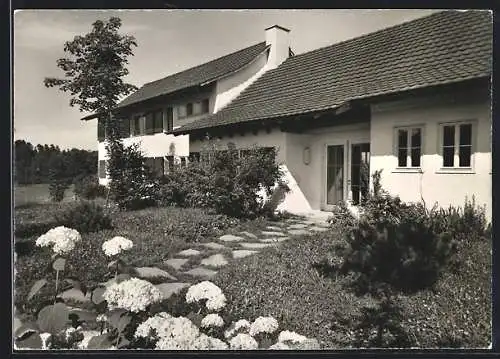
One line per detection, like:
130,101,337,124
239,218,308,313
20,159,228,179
118,42,266,108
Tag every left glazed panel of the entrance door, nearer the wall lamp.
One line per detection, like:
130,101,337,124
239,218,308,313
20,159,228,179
326,145,345,206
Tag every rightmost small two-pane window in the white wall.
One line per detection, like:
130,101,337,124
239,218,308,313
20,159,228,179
441,123,473,168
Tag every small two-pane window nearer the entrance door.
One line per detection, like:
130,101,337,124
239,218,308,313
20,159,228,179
396,127,422,167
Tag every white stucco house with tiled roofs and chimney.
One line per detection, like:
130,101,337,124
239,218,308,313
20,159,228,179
82,11,493,218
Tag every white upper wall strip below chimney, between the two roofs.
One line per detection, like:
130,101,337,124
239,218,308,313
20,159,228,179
214,52,268,112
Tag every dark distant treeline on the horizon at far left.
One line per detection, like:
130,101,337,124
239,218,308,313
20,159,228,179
13,140,98,184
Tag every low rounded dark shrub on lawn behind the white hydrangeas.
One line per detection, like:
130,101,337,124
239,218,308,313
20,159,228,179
54,201,112,233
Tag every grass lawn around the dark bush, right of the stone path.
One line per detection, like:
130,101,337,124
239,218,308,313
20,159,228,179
215,232,491,349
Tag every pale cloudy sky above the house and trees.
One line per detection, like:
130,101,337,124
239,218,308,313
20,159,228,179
13,9,434,150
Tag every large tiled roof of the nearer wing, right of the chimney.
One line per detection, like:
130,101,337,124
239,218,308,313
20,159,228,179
173,11,493,133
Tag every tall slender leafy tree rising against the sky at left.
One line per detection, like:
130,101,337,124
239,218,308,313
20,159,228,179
44,17,137,208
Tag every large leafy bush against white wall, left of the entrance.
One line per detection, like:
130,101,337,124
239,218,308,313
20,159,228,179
158,144,287,218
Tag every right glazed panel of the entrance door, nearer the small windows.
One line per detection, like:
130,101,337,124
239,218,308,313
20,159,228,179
351,143,370,205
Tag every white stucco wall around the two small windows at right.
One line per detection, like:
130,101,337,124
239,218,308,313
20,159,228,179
370,91,492,218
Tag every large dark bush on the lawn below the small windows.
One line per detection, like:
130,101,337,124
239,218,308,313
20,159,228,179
342,172,452,293
